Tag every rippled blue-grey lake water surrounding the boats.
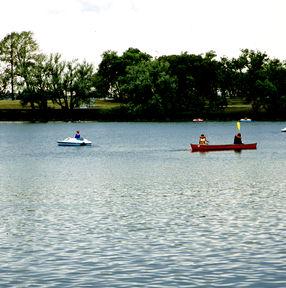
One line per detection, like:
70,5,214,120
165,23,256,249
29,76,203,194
0,122,286,288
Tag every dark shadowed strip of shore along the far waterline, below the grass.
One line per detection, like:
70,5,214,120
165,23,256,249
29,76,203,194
0,108,286,122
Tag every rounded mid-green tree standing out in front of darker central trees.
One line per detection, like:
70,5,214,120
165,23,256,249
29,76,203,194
120,60,177,117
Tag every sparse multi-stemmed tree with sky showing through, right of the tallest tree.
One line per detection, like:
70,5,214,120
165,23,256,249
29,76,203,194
20,54,97,110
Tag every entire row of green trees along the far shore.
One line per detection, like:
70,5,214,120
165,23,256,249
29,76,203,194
0,31,286,116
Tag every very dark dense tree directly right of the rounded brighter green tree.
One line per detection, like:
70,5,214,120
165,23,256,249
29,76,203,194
159,51,226,115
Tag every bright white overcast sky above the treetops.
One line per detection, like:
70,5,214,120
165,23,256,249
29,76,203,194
0,0,286,65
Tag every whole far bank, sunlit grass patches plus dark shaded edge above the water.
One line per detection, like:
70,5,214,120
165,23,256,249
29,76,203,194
0,100,286,121
